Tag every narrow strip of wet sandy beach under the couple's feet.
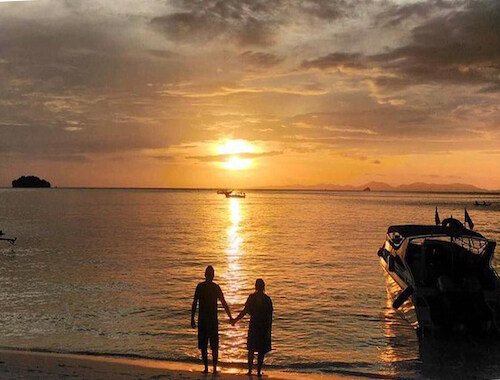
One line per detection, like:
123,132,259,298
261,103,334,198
0,349,358,380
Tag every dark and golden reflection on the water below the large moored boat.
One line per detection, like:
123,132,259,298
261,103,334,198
381,298,500,380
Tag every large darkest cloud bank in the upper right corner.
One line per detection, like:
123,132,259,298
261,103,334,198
302,0,500,88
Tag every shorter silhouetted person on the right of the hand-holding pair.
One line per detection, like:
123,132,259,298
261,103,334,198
231,278,273,376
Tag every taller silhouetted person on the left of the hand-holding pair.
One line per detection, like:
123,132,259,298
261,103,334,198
191,265,232,373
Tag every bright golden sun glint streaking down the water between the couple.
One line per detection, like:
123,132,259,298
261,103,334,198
220,198,249,363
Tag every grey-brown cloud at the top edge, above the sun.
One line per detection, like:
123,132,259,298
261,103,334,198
151,0,358,47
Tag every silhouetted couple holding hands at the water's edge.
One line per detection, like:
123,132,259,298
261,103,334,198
191,265,273,376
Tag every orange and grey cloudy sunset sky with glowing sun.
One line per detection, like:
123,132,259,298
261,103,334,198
0,0,500,189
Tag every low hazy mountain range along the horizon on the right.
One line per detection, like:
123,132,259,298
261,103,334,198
270,181,488,193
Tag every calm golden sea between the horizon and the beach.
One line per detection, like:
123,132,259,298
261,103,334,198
0,189,500,379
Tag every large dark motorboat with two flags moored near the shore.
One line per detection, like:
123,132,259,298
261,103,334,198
378,208,500,333
